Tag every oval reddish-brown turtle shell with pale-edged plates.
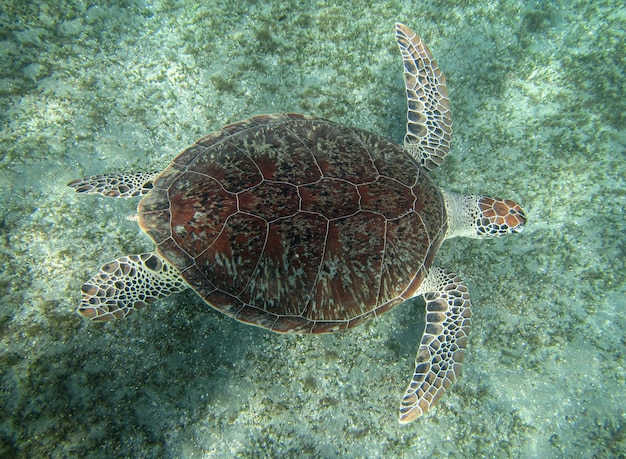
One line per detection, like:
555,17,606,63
138,114,447,333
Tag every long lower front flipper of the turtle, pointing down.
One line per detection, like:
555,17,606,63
399,267,472,424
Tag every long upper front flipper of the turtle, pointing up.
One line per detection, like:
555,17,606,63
396,24,452,171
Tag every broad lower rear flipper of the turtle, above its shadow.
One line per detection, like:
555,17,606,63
77,253,187,322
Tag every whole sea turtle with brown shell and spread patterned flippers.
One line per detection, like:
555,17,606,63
69,24,526,423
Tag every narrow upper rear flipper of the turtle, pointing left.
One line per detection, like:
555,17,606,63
67,172,159,198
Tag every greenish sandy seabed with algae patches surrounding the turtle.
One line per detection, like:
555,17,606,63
0,0,626,458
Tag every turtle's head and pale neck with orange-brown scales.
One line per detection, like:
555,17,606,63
442,191,526,239
